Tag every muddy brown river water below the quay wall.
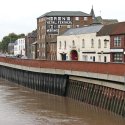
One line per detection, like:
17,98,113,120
0,79,125,125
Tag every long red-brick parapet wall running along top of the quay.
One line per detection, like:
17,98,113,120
0,57,125,76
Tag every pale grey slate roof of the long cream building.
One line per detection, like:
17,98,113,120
63,25,103,35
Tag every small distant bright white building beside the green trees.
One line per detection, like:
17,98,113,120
14,38,25,56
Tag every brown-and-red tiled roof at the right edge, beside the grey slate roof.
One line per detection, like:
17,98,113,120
97,22,125,36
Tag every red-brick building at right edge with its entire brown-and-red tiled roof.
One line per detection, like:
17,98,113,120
98,22,125,62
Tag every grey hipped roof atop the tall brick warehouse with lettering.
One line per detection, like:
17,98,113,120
38,11,91,18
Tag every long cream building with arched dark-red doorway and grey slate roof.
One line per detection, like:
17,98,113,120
57,25,110,62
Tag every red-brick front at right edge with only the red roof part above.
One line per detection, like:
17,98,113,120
110,22,125,62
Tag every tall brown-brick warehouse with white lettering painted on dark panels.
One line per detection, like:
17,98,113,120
37,11,93,60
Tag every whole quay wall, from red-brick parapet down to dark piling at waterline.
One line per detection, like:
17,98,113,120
0,58,125,117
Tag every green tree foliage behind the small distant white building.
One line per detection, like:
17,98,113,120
0,33,25,53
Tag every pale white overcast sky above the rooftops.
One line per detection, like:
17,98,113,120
0,0,125,40
